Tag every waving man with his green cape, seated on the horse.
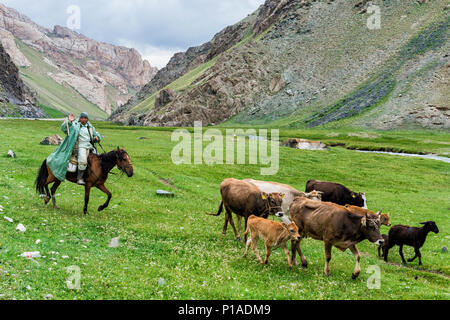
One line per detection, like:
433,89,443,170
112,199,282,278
47,112,101,185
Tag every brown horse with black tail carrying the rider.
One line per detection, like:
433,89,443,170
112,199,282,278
35,147,133,214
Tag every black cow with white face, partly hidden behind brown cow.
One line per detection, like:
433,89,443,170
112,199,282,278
306,180,367,209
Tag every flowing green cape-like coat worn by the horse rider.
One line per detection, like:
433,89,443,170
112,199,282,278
47,119,101,181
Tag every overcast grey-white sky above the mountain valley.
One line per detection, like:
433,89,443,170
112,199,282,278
0,0,264,68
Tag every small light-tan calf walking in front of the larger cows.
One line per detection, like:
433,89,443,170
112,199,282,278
244,215,300,268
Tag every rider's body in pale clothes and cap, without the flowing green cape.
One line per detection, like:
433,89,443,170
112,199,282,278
61,112,101,185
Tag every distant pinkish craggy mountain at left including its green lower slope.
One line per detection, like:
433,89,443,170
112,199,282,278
0,4,157,118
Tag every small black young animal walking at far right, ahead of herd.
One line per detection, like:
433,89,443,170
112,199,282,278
383,221,439,266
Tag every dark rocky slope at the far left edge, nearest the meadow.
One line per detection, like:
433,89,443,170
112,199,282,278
0,44,48,118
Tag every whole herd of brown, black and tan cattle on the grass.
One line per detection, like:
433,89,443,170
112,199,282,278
210,178,439,279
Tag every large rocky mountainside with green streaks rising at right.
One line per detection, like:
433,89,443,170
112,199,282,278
110,0,450,129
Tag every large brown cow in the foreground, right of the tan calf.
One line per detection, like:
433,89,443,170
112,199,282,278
290,198,384,279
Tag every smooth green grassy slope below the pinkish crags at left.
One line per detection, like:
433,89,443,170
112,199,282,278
16,40,107,119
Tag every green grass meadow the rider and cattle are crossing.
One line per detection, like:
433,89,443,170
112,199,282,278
0,120,450,300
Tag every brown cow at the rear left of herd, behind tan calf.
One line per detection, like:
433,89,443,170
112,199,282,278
210,178,284,241
